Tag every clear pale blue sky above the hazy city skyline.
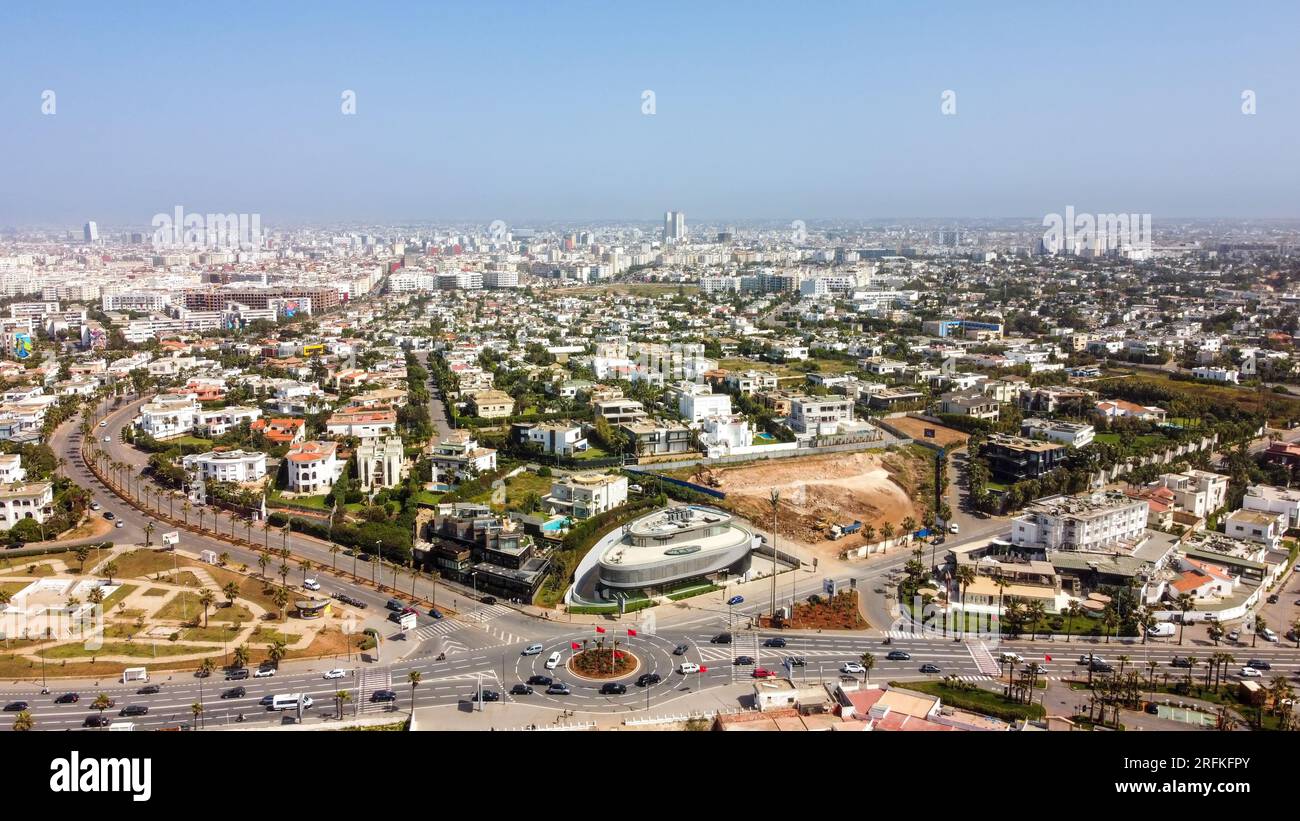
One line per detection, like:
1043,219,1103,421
0,1,1300,225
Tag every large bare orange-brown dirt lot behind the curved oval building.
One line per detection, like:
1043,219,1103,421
690,451,930,546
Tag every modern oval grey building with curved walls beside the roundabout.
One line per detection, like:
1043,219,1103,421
595,505,758,596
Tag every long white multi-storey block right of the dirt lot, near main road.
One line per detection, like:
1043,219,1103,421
1011,492,1148,552
